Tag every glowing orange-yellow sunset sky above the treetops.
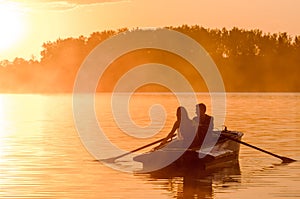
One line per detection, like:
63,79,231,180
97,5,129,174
0,0,300,60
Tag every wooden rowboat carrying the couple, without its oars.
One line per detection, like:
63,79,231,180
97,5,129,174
133,131,243,173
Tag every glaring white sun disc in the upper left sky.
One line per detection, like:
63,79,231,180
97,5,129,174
0,1,25,52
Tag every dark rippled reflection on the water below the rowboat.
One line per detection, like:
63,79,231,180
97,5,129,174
139,162,241,199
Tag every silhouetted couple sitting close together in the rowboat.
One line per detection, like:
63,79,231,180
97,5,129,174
154,103,214,150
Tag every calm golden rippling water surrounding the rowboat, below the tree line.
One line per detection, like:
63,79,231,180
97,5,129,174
0,93,300,199
